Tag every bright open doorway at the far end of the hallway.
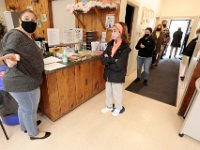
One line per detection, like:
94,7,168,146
167,19,191,55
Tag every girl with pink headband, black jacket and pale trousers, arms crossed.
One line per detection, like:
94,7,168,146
101,22,131,116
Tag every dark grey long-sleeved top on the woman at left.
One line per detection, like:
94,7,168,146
2,29,44,92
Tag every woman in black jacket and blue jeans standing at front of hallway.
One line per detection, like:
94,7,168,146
135,28,155,85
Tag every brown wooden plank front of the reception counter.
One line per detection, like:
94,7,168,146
39,57,105,121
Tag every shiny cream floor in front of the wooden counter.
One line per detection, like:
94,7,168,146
0,72,200,150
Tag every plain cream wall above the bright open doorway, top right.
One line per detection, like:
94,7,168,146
159,0,200,16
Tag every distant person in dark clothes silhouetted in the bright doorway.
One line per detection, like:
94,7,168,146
169,27,183,58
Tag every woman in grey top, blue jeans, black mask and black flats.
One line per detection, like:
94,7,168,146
2,9,51,140
